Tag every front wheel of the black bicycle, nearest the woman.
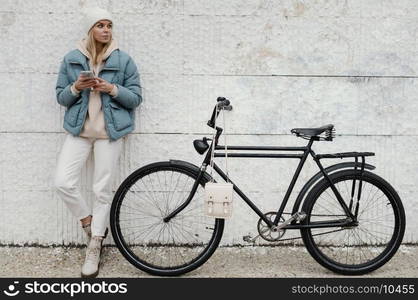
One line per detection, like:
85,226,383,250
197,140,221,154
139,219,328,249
110,161,224,276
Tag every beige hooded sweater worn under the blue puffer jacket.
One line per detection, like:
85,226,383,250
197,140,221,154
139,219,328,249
71,39,118,139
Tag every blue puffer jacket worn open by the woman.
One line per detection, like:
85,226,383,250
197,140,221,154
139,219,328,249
56,49,142,141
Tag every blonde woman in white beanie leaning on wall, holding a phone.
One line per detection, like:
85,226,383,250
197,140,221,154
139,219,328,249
55,8,142,277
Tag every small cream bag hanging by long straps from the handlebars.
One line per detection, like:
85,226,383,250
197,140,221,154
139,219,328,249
205,105,234,219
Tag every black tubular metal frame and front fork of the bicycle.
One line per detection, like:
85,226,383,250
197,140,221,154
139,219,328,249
164,134,356,229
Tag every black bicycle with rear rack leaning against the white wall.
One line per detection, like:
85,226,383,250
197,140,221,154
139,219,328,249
110,97,405,276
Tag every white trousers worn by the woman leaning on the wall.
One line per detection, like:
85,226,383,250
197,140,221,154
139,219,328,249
54,134,122,236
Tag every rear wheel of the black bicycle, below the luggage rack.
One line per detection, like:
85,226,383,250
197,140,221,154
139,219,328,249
301,170,405,275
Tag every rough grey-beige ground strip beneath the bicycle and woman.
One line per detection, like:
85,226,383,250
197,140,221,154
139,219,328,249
0,246,418,278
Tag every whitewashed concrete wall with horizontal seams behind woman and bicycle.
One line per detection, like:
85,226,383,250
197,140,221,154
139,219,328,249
0,0,418,245
